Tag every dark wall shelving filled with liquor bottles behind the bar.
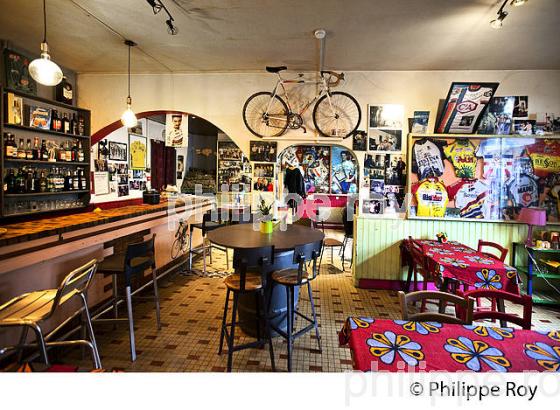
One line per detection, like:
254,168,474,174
0,87,91,217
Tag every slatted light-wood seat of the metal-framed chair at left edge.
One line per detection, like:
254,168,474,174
0,289,75,325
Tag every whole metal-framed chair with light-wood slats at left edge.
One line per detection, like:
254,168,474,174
0,259,101,369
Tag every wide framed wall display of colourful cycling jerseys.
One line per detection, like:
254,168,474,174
408,135,560,222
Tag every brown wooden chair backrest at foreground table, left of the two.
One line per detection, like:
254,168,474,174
399,290,474,325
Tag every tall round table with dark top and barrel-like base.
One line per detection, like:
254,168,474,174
208,224,325,335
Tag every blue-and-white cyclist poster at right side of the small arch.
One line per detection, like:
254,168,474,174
331,146,358,194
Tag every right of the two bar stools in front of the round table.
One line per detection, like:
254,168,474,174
272,241,323,372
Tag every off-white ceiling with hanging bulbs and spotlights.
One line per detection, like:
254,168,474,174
0,0,560,73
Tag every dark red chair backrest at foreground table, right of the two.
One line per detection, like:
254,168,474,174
459,289,533,330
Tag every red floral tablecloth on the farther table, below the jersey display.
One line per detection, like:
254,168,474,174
415,239,519,294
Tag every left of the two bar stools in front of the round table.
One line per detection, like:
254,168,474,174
218,246,276,372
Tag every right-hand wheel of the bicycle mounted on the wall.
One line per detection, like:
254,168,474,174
313,91,362,138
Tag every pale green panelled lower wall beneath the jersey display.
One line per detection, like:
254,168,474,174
353,217,527,284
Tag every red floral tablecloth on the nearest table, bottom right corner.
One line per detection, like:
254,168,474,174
339,317,560,372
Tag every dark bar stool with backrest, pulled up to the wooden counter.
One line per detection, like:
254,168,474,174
93,234,161,361
